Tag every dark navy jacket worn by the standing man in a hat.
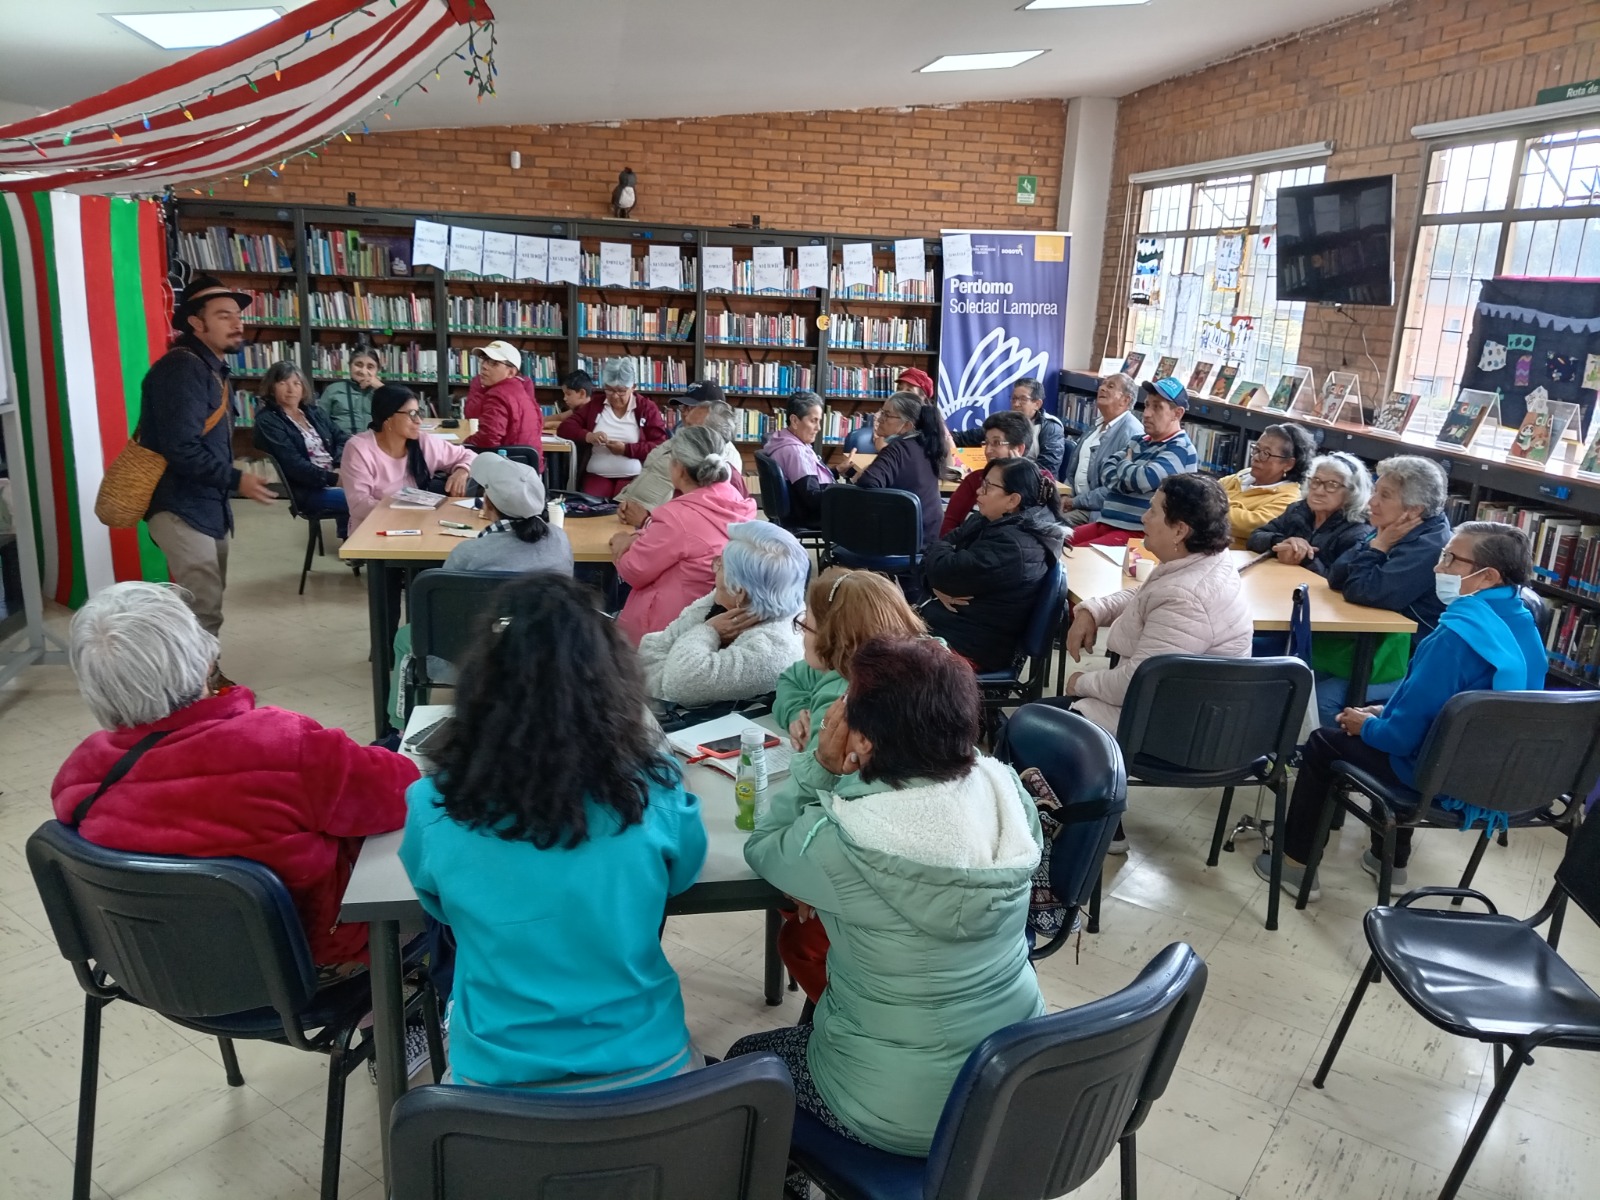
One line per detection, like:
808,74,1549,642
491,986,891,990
139,334,238,538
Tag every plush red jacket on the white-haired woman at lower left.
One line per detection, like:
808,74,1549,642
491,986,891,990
50,688,418,965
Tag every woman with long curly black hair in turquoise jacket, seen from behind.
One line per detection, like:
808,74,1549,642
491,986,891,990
400,571,706,1091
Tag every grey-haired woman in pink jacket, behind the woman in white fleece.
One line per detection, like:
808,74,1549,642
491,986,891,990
611,426,755,645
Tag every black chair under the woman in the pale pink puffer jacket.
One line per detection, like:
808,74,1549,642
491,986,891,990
1117,654,1315,930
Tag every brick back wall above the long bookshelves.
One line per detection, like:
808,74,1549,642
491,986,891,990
202,99,1066,235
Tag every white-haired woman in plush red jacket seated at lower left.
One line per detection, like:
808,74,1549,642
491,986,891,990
50,582,418,966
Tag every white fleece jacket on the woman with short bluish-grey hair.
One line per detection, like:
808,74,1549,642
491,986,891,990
638,594,805,709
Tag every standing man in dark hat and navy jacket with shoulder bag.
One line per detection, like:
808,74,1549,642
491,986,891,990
139,275,277,659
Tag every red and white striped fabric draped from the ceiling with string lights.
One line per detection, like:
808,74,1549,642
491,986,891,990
0,0,493,192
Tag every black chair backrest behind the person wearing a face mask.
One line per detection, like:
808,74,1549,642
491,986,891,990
1416,691,1600,813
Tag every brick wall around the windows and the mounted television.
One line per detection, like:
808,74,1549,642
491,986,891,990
1094,0,1600,392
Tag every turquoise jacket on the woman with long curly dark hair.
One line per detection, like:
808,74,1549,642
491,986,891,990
400,778,706,1086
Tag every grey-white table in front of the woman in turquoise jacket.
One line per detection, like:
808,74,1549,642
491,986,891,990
339,704,782,1187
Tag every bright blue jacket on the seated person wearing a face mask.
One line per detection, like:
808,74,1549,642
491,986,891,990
1362,587,1546,787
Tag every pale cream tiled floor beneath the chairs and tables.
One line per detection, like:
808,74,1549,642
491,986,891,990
0,504,1600,1200
